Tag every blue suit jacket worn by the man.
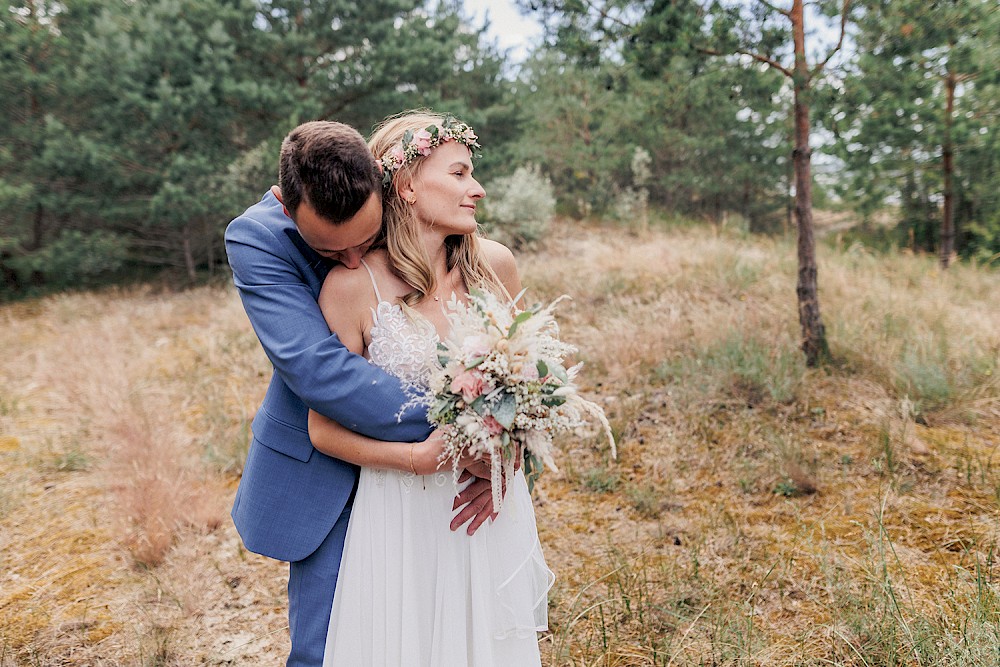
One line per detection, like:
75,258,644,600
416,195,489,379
226,192,431,561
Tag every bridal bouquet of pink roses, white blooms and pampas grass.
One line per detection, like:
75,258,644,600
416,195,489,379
414,290,617,509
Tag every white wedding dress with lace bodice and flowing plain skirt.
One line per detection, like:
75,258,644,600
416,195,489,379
323,264,554,667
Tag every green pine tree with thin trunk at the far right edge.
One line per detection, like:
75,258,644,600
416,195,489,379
832,0,1000,268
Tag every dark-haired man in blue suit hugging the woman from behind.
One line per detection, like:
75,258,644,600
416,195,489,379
226,121,493,667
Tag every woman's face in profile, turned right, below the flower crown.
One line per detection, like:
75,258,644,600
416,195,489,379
403,141,486,235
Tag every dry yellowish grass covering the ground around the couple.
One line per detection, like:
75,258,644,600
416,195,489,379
0,225,1000,667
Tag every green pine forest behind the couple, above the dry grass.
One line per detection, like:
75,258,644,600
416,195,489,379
0,0,1000,290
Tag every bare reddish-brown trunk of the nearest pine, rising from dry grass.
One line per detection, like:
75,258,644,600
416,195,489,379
790,0,830,366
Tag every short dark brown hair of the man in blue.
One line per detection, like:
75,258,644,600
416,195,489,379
278,120,382,225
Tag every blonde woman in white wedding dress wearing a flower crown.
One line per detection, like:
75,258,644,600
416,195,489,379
309,112,553,667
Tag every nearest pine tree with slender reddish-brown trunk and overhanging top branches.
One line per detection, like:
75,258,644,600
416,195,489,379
519,0,851,366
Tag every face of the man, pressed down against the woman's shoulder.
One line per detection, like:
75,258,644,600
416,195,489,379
276,185,382,269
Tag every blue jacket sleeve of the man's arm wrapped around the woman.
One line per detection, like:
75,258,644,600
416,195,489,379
226,215,431,442
